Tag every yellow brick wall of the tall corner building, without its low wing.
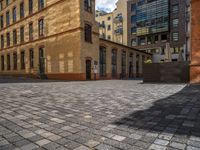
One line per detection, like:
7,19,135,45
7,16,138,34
0,0,151,80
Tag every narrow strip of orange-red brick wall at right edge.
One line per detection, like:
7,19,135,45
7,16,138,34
190,0,200,83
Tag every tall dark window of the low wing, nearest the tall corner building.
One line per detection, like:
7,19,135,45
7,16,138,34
99,47,106,77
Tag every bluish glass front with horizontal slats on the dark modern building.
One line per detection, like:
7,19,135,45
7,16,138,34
136,0,169,36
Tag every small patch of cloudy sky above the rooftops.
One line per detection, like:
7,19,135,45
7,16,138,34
96,0,118,12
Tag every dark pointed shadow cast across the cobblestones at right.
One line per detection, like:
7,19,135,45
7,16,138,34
113,85,200,137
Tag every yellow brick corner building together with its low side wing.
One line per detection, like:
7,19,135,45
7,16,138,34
0,0,151,80
